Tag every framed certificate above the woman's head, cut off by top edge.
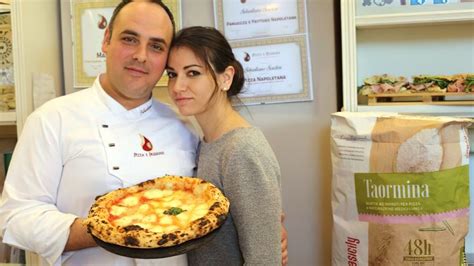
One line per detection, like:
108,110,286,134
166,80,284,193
214,0,306,40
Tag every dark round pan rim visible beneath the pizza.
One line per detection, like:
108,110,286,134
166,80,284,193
92,227,225,259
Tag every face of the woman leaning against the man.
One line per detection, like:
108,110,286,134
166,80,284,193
166,47,225,116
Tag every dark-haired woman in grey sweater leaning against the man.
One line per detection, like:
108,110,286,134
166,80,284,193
167,27,282,265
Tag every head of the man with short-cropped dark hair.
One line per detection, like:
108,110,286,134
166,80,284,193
100,2,173,109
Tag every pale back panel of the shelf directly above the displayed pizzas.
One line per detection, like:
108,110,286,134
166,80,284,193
357,23,474,85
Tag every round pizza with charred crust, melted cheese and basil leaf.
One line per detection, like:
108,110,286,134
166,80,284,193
84,176,229,248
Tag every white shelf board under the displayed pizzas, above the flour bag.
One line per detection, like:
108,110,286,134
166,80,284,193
357,104,474,118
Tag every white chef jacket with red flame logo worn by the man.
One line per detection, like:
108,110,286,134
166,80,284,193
0,76,198,265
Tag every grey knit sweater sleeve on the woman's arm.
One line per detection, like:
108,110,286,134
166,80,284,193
222,138,281,265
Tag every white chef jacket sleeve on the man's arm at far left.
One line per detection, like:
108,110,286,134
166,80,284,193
0,110,76,264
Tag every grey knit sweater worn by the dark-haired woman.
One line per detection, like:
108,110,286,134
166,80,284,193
188,127,282,266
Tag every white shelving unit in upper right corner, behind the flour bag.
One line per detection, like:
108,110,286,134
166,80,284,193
341,0,474,117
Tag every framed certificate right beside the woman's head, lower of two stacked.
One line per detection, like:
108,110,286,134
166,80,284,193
231,35,313,104
